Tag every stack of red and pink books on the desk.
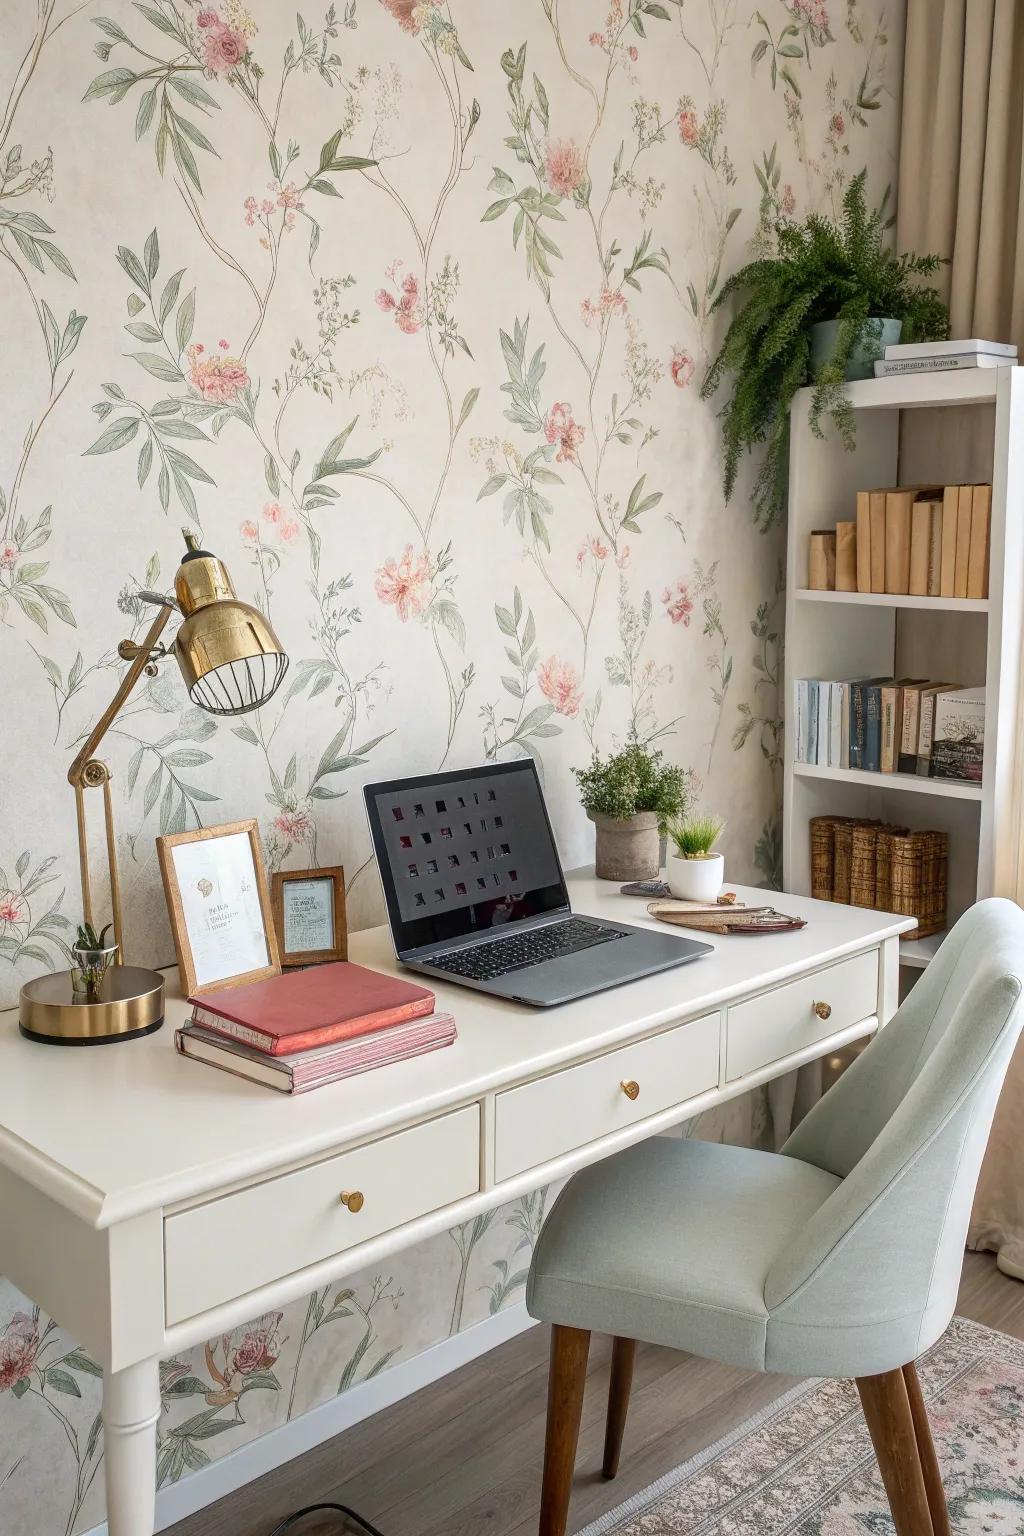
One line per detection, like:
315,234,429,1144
175,962,456,1094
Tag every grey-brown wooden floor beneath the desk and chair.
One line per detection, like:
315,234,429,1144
172,1253,1024,1536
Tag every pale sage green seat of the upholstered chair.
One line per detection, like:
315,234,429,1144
527,1137,840,1370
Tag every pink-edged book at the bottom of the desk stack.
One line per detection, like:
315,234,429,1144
175,1014,456,1094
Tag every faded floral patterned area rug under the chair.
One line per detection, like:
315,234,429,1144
580,1318,1024,1536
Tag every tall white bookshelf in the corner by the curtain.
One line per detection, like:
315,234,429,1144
783,367,1024,969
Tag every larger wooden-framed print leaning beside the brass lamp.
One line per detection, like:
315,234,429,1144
157,822,281,997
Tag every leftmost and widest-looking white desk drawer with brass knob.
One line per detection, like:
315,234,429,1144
164,1104,481,1324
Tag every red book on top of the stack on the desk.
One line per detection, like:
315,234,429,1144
189,960,434,1055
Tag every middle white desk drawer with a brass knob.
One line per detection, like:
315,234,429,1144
494,1014,720,1183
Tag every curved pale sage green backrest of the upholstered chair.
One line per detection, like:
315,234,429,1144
765,899,1024,1375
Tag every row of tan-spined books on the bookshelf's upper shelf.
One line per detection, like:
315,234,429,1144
808,484,992,598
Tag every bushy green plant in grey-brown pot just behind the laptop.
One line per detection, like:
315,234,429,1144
573,740,685,880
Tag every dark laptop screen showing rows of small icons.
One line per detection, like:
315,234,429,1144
362,759,568,954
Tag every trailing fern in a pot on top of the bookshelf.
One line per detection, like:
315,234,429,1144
702,170,949,527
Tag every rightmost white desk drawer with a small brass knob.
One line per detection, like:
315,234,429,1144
725,949,878,1083
